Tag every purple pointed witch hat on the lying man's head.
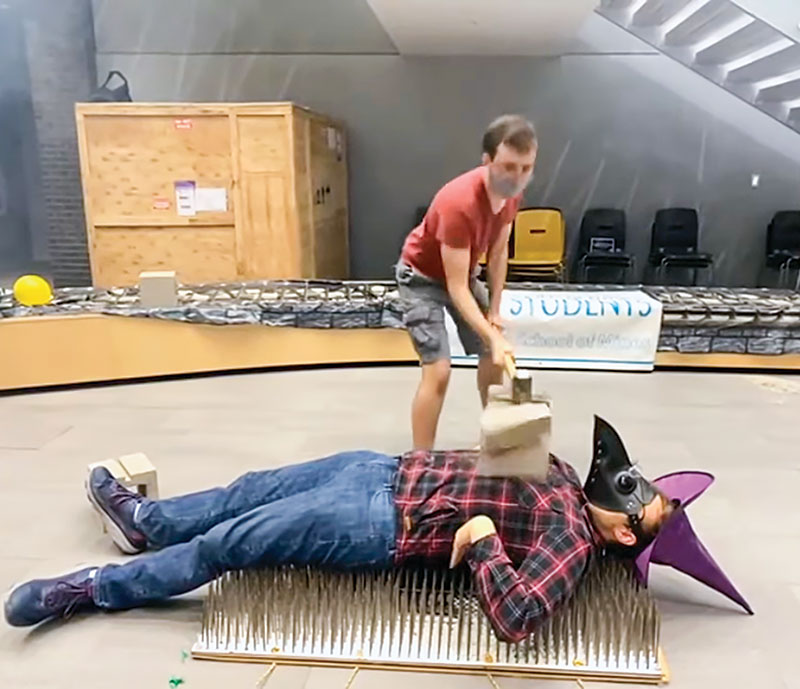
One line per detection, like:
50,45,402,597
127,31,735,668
634,471,753,615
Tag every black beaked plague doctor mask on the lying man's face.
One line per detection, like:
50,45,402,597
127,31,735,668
583,416,658,542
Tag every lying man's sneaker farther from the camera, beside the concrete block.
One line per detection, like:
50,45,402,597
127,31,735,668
86,467,147,555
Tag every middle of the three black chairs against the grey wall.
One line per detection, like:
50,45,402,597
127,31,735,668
649,208,714,285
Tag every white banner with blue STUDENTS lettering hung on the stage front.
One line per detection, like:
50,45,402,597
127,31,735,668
446,290,662,371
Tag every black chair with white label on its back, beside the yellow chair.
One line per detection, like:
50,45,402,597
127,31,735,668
578,208,634,282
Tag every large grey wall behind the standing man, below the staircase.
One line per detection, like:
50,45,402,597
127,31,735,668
96,0,800,285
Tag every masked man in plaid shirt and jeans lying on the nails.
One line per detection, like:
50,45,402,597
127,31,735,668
5,418,673,641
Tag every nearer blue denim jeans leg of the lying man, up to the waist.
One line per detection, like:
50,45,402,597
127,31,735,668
95,455,397,609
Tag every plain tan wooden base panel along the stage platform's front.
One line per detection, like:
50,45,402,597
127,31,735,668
0,314,800,390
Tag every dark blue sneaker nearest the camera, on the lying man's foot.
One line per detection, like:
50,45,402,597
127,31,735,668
3,567,97,627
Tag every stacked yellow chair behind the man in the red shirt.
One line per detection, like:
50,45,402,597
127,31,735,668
508,208,566,282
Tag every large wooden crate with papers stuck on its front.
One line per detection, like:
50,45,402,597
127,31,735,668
76,103,349,287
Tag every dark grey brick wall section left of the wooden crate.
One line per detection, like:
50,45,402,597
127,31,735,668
16,0,97,285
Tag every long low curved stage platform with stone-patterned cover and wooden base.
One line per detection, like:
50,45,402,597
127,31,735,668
0,281,800,390
